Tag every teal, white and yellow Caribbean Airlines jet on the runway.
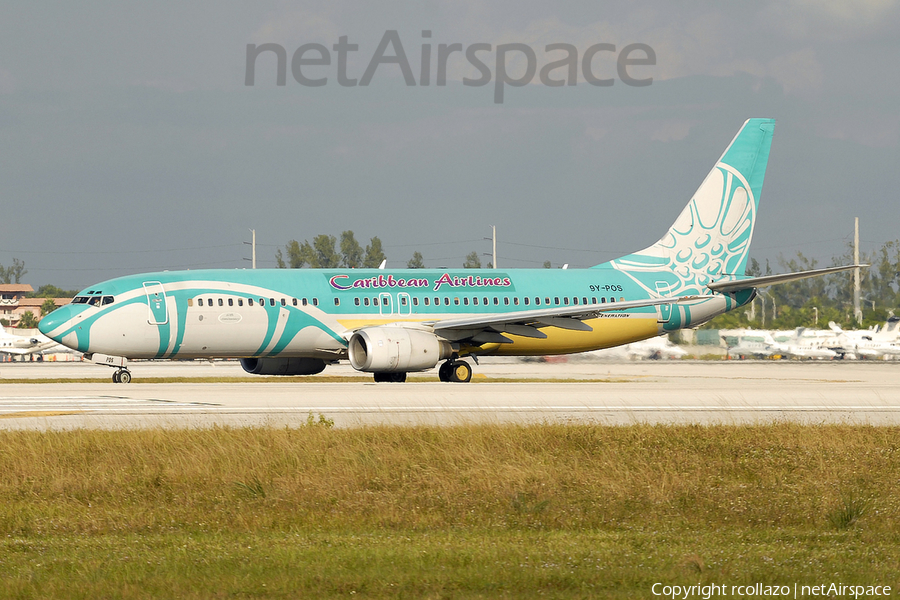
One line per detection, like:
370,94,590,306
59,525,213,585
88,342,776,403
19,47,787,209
40,119,854,383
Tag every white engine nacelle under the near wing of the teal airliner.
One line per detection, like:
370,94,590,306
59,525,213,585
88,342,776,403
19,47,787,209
348,327,453,373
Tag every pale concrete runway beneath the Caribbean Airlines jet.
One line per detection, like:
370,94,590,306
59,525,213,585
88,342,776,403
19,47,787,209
0,360,900,429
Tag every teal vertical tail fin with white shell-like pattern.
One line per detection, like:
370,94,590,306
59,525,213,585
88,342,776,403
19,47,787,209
598,119,775,293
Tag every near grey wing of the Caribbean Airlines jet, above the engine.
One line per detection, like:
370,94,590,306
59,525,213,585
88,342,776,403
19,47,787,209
425,296,705,343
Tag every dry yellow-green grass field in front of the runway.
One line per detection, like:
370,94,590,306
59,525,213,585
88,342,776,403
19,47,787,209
0,424,900,598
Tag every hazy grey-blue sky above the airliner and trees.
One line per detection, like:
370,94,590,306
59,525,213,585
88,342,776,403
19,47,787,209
0,0,900,289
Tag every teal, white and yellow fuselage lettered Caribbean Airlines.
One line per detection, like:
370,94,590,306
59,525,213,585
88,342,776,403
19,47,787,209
40,266,750,360
